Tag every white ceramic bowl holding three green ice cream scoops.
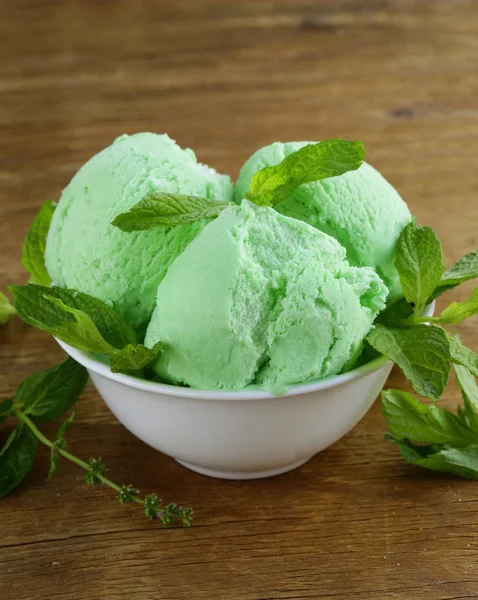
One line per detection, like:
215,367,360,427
57,306,433,479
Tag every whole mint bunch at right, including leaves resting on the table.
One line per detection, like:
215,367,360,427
376,221,478,479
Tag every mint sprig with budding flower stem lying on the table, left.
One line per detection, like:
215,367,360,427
0,358,192,527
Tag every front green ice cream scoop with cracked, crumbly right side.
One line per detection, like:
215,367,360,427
145,201,387,389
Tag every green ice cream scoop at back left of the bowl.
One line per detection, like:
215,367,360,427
45,133,232,329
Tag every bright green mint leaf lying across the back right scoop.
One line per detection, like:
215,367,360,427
245,139,365,206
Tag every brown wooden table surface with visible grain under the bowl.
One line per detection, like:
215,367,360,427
0,0,478,600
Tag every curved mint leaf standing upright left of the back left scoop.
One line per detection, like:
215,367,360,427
22,200,56,286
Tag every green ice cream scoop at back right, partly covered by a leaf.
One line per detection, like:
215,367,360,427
234,142,411,296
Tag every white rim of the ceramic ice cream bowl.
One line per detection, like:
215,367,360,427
55,301,435,401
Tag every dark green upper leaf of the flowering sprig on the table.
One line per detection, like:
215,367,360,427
17,358,88,421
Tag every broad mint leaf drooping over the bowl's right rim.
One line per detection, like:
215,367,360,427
366,324,450,400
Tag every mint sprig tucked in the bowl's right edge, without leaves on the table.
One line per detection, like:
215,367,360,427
366,221,478,400
